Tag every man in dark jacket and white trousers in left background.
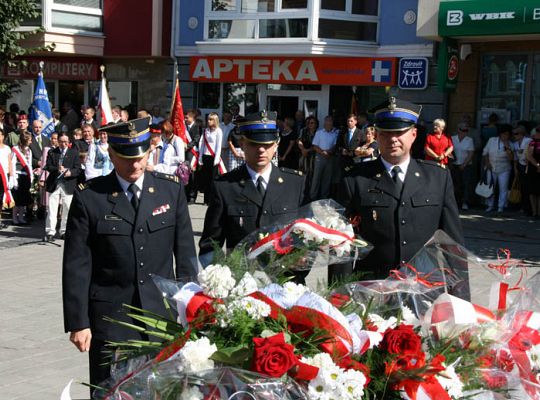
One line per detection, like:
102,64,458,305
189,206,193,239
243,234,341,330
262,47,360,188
44,133,81,242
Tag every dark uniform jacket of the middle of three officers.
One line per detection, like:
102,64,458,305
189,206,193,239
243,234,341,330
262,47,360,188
199,165,305,254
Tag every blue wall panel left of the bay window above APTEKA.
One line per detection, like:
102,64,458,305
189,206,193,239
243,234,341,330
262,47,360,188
175,0,204,46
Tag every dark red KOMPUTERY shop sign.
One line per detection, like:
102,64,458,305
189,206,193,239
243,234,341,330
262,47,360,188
6,58,99,81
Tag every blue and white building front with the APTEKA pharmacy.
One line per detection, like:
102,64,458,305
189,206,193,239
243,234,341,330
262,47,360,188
172,0,443,124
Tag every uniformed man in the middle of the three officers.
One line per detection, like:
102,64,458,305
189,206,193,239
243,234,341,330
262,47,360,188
199,111,305,281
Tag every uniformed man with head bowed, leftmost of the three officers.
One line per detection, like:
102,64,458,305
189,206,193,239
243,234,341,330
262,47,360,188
62,117,197,385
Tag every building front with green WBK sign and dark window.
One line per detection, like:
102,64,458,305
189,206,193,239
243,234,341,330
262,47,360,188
418,0,540,134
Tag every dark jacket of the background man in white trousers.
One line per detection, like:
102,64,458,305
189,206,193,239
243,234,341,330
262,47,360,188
44,147,81,194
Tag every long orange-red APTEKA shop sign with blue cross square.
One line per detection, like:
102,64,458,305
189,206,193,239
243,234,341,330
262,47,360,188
190,56,396,86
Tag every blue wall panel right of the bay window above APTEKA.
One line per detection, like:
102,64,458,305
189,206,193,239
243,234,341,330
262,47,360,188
379,0,431,46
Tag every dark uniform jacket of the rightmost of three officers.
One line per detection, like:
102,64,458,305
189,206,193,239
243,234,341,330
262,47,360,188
338,158,463,278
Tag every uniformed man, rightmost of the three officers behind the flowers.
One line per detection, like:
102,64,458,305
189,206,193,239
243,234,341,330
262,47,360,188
331,97,463,279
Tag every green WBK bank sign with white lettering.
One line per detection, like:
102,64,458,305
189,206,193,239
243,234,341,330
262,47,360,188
439,0,540,36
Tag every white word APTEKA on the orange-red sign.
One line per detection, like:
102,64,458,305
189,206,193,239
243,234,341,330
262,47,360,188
192,58,319,82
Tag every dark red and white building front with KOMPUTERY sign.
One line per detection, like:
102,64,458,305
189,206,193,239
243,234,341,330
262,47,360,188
3,0,173,120
